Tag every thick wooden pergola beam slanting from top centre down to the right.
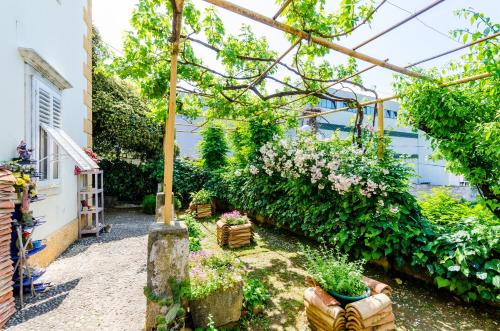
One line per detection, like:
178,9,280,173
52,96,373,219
203,0,430,79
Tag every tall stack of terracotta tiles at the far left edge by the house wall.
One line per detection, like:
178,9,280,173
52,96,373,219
0,169,16,328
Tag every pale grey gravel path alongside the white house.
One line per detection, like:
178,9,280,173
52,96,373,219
7,211,153,331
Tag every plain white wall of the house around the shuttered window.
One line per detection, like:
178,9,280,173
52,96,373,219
0,0,86,238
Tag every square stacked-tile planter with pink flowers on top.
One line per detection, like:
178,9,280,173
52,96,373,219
217,210,253,248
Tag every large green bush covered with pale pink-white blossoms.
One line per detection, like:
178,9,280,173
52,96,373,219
218,135,425,260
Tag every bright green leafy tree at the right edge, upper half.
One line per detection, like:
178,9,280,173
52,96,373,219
395,9,500,216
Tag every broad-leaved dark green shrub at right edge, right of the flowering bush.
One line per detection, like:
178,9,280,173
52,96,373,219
413,218,500,302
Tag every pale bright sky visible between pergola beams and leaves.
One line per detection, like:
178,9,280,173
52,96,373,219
92,0,500,96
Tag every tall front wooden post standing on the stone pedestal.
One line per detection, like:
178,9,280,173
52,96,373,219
163,0,184,224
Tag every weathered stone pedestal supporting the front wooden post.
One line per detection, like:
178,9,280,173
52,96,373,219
146,193,189,330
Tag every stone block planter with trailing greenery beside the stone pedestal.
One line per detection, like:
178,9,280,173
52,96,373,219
189,251,243,328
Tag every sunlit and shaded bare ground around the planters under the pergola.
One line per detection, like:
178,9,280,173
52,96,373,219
194,218,500,330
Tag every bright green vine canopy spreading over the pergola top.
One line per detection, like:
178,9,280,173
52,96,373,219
114,0,378,122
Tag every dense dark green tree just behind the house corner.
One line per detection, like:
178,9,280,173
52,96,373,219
92,29,162,160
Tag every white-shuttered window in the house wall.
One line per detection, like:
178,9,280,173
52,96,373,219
32,77,62,181
